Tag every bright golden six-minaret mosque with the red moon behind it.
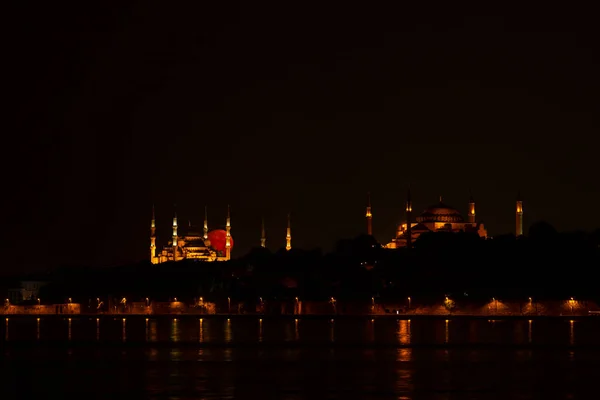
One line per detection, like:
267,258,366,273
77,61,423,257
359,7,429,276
150,206,292,264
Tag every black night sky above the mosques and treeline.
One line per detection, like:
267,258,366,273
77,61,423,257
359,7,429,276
0,1,600,272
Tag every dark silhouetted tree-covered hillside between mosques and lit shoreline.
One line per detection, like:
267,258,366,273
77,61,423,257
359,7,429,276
27,223,600,302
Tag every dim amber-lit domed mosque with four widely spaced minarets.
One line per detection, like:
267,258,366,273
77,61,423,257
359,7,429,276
366,190,523,249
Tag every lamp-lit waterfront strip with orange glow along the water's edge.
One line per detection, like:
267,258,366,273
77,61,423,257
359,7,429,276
0,298,600,318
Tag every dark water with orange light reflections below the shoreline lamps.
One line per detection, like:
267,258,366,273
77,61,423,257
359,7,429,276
0,317,600,399
